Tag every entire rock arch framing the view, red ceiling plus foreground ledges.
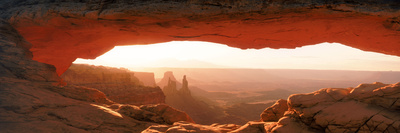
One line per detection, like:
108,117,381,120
0,0,400,133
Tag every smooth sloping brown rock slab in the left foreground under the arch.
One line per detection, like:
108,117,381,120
0,21,193,133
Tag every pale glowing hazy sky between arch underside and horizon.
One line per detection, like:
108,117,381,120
74,41,400,71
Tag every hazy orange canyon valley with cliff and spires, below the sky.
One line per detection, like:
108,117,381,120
61,64,400,125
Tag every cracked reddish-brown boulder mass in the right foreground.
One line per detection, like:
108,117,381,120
270,83,400,133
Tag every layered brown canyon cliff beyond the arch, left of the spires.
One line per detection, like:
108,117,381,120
61,64,165,105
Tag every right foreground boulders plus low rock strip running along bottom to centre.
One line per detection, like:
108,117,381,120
143,83,400,133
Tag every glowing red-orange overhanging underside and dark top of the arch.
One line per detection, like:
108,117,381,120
0,0,400,75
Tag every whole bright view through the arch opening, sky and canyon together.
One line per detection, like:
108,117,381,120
61,41,400,124
